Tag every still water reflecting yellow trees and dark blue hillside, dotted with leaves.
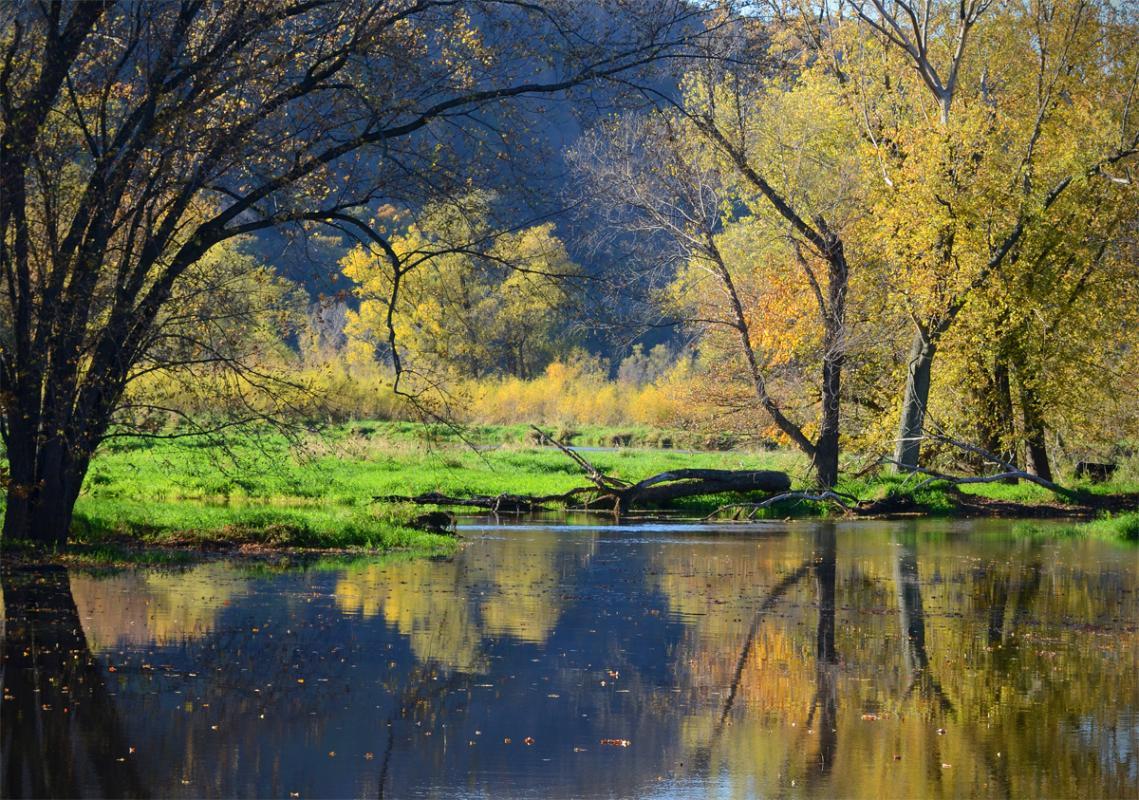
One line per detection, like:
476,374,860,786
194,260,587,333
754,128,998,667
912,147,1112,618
0,522,1139,799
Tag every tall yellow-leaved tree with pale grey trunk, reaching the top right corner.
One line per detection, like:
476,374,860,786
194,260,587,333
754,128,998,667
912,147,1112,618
828,0,1139,472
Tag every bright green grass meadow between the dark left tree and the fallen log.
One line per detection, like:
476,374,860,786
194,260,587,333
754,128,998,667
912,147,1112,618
28,422,801,551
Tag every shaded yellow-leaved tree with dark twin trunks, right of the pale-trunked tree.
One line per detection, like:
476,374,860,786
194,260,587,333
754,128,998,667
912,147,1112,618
931,176,1139,480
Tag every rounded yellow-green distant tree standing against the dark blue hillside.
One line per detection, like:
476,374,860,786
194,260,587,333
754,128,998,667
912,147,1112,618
342,195,580,383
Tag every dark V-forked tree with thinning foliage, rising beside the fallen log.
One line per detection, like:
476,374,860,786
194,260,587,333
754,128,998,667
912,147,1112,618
574,64,859,487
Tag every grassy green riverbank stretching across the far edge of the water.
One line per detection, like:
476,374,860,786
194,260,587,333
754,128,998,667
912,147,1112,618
0,423,1139,561
